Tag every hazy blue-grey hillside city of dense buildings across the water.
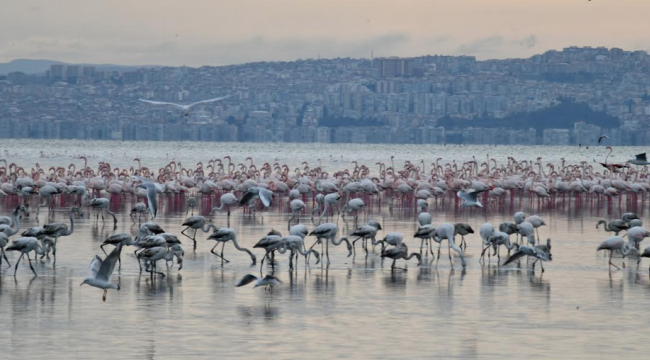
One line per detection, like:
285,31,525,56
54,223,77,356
0,47,650,145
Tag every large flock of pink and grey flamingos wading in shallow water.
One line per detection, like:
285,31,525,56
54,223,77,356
0,150,650,301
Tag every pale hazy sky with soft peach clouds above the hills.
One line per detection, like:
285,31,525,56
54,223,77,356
0,0,650,66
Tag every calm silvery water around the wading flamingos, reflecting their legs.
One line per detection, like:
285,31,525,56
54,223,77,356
0,141,650,359
